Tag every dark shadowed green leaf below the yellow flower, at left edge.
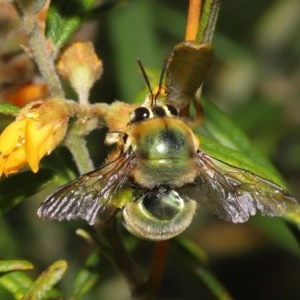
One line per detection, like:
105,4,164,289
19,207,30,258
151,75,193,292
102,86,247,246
0,169,54,216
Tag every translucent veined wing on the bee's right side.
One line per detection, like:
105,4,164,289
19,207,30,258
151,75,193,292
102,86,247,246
197,151,299,223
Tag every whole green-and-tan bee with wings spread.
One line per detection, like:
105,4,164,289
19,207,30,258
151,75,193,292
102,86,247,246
38,41,298,241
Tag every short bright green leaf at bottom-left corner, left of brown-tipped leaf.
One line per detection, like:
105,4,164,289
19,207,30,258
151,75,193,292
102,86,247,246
0,271,32,299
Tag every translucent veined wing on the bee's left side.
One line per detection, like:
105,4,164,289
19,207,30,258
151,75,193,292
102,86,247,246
38,153,134,225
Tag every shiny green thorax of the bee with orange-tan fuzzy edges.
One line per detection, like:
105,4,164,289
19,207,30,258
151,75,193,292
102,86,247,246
128,118,197,188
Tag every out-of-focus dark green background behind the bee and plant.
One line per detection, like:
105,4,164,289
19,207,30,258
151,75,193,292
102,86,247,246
0,0,300,300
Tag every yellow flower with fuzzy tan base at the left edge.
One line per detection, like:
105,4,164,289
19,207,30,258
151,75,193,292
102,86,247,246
0,98,71,177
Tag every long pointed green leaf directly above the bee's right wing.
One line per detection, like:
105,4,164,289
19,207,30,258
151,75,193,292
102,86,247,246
196,98,285,186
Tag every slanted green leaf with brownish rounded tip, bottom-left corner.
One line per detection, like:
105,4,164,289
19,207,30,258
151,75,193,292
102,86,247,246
22,260,67,300
